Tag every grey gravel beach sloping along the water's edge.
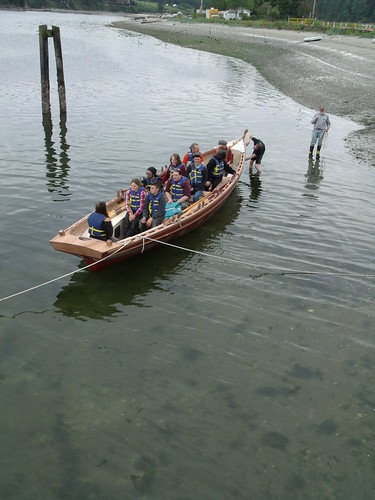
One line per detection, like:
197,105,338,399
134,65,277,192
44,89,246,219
112,16,375,166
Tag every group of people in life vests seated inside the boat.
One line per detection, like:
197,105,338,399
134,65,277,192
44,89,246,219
88,140,235,241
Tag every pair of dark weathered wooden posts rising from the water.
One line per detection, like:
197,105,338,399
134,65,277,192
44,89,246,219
39,24,66,114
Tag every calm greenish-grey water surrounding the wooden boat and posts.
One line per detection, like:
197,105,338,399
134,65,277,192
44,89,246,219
0,12,375,499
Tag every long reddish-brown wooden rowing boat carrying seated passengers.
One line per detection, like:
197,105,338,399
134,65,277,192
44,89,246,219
50,130,247,271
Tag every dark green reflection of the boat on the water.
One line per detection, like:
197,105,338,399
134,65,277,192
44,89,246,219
54,187,242,321
